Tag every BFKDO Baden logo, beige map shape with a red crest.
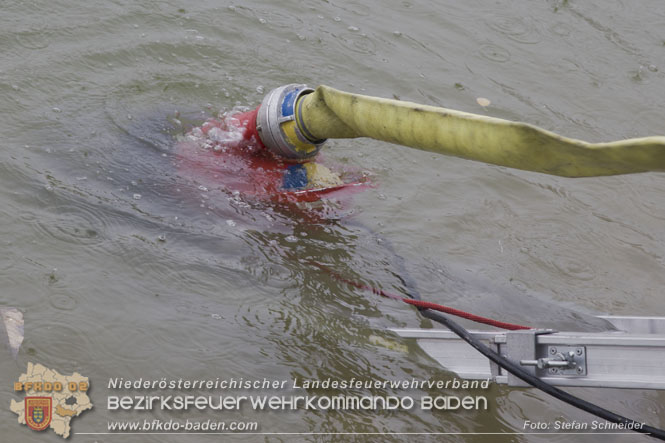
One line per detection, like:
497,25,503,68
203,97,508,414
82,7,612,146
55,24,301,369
9,363,92,438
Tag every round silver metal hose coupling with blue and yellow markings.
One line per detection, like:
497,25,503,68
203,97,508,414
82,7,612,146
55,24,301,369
256,84,325,160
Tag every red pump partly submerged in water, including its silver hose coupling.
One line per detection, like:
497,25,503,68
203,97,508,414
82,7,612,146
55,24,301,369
192,84,370,202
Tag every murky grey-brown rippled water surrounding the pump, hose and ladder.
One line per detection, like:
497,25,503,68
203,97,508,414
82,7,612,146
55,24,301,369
0,0,665,441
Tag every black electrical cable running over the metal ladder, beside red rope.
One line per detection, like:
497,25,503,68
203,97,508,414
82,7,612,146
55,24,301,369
412,306,665,441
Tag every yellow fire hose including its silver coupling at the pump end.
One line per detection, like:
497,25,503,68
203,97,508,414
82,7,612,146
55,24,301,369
257,85,665,177
